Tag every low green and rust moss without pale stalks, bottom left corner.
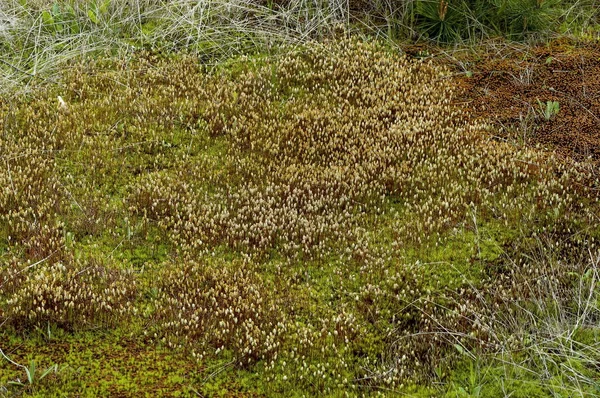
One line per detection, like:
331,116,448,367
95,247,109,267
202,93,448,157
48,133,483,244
0,329,220,397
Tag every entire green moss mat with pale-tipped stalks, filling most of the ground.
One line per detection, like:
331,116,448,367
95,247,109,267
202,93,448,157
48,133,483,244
0,40,600,396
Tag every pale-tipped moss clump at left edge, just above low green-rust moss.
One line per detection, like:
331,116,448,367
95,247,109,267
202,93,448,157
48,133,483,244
0,258,137,330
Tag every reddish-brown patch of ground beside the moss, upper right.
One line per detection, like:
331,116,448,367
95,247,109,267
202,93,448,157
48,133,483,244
407,39,600,165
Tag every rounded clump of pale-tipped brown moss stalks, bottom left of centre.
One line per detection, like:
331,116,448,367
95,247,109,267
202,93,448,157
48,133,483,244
150,261,285,366
